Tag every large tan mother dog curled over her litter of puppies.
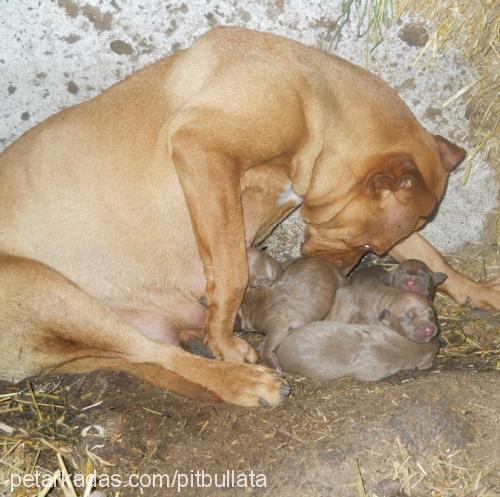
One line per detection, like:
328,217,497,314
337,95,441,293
0,28,500,406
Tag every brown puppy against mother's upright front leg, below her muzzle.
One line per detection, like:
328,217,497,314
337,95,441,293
237,253,346,371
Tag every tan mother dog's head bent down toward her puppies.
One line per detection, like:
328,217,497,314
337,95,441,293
301,134,465,268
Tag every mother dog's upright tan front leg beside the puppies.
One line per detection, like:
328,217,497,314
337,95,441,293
171,126,257,362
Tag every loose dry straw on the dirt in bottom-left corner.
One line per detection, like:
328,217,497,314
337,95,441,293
0,381,107,497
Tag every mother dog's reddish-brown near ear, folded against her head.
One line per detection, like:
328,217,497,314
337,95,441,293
366,154,436,217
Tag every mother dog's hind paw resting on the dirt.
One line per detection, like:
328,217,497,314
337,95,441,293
217,364,290,407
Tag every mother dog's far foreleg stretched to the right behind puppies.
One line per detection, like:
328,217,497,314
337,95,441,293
390,233,500,310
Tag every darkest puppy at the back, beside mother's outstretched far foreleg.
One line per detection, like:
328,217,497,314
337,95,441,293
349,259,447,300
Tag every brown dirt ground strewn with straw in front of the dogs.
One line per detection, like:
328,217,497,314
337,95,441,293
0,262,500,497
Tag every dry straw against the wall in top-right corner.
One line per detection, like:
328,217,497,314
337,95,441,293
404,0,500,181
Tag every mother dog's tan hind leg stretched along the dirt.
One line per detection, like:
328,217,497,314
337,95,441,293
0,256,289,406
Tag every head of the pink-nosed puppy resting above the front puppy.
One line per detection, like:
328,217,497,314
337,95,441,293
379,291,438,343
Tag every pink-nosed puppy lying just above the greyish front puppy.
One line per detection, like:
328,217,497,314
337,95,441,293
327,280,438,343
